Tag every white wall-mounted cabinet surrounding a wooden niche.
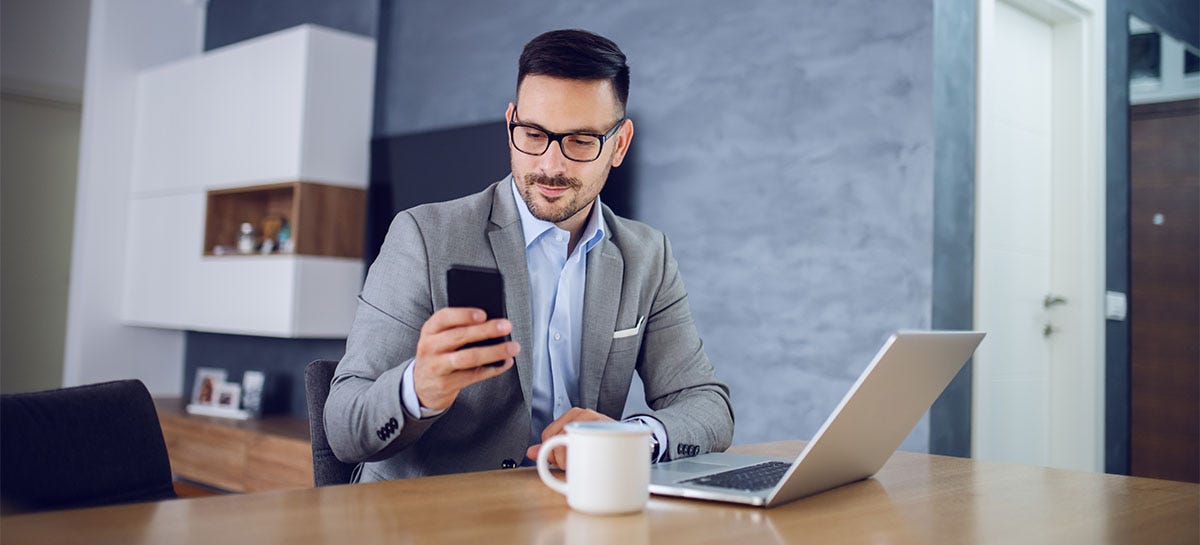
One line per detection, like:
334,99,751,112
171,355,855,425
122,25,374,337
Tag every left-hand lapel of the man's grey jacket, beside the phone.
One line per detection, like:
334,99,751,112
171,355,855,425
487,176,533,407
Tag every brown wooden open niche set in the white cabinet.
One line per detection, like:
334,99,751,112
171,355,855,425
204,181,366,258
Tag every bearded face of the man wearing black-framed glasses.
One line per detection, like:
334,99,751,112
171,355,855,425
505,76,634,232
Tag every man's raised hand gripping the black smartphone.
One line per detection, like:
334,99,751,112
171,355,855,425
413,307,521,411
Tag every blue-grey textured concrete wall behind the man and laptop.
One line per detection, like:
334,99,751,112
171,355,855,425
376,0,934,450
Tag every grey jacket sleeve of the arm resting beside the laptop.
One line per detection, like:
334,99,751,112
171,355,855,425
637,236,733,459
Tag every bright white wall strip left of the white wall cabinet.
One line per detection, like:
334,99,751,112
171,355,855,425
64,0,205,395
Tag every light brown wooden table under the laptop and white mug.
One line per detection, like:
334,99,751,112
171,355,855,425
0,441,1200,545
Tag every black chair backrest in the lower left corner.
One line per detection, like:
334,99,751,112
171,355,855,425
0,381,175,511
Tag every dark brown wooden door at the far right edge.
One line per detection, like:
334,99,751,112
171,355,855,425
1129,100,1200,483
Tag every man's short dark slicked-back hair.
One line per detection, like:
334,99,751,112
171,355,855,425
517,29,629,109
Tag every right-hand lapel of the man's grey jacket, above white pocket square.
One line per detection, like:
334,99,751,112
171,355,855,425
580,217,625,409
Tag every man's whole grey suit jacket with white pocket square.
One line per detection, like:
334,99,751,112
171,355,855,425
325,176,733,481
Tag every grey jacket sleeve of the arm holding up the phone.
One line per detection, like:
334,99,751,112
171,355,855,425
325,211,437,463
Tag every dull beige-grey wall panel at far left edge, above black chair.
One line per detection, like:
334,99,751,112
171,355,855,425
0,92,79,394
